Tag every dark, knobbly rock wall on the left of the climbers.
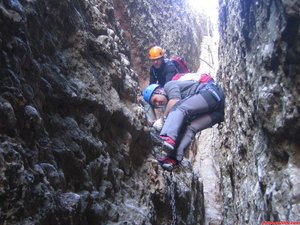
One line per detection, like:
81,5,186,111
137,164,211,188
0,0,203,225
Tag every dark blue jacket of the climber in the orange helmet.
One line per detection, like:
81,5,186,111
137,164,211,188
150,59,179,87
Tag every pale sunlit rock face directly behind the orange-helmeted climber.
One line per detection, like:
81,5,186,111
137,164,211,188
114,0,207,90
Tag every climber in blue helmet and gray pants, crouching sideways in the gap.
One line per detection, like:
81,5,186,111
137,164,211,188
143,74,225,170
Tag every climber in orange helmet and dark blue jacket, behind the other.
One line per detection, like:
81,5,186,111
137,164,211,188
149,46,181,87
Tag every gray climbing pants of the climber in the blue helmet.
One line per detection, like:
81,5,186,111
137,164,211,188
160,85,224,161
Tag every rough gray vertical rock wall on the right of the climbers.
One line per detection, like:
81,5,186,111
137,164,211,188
216,0,300,224
